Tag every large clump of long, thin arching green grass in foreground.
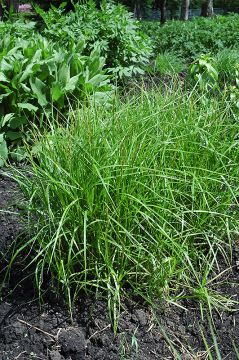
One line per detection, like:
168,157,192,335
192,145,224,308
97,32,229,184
10,88,239,322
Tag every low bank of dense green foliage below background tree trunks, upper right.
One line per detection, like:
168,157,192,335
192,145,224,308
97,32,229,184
142,14,239,62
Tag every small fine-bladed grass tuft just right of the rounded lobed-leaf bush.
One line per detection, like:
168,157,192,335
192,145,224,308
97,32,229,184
154,52,186,75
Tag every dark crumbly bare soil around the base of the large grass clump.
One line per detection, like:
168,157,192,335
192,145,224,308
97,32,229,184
0,169,239,360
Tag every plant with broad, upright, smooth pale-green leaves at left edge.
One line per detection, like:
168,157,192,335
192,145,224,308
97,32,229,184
0,34,112,163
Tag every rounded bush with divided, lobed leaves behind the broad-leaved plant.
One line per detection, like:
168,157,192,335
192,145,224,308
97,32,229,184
38,2,151,77
